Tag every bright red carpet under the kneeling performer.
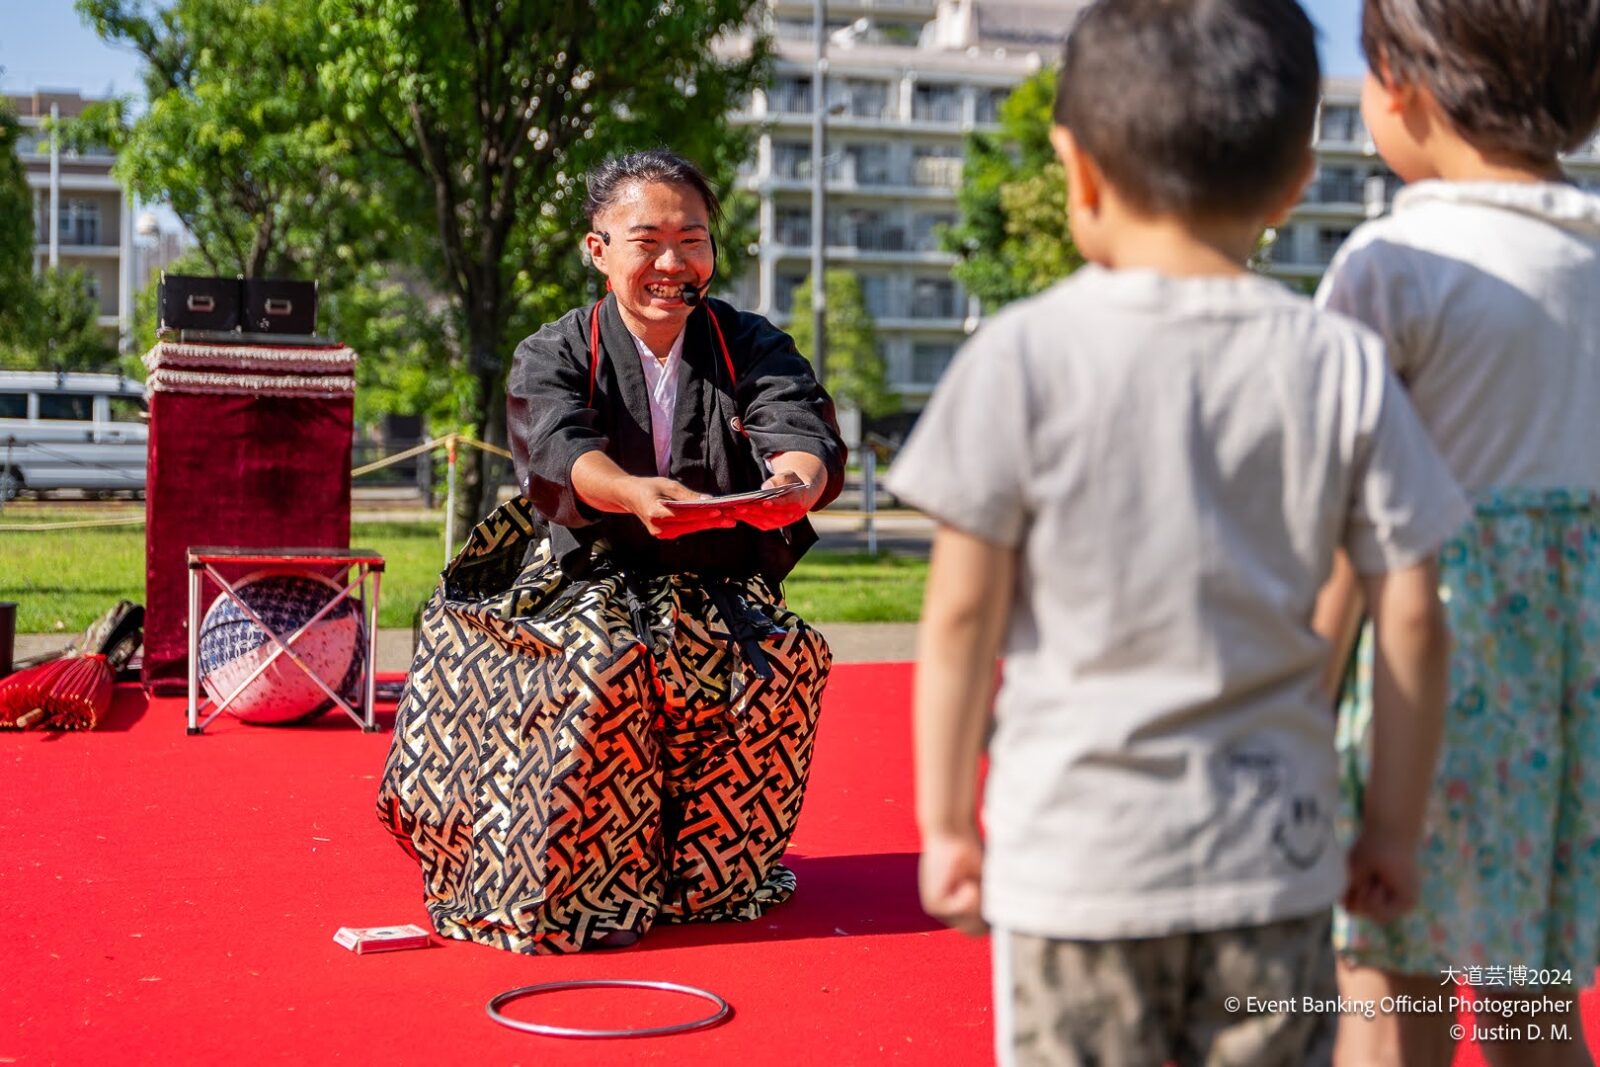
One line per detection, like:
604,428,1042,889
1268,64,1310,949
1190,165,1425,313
0,664,1600,1065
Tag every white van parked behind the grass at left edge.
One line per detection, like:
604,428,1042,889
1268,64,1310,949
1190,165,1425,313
0,371,149,501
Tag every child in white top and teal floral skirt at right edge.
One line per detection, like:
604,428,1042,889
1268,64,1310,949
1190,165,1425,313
1318,0,1600,1067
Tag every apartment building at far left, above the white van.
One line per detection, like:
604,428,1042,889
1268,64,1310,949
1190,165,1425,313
6,90,134,346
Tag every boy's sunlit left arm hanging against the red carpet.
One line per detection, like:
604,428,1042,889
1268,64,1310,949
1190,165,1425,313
914,525,1016,934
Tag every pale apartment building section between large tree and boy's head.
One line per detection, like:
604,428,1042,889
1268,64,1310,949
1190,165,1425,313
734,0,1078,405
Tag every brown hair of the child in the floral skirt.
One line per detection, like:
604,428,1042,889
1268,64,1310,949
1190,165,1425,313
1362,0,1600,162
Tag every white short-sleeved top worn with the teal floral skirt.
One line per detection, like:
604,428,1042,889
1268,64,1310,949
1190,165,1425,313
1317,181,1600,491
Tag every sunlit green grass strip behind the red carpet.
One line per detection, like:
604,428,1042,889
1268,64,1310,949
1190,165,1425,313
0,504,928,633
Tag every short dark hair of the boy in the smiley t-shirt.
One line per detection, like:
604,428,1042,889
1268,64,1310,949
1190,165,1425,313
1054,0,1322,218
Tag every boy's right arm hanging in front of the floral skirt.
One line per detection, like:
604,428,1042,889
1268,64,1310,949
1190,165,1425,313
1344,560,1450,921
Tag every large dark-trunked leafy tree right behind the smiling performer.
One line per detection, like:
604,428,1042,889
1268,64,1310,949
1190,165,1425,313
318,0,766,533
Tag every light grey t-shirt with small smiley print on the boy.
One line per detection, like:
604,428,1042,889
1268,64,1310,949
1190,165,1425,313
890,267,1466,939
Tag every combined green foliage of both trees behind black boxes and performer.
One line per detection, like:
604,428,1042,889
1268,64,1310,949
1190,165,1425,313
77,0,768,525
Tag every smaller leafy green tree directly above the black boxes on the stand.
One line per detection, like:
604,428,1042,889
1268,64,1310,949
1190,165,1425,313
76,0,397,286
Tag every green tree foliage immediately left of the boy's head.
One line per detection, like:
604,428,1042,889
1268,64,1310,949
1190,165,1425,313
942,69,1083,312
